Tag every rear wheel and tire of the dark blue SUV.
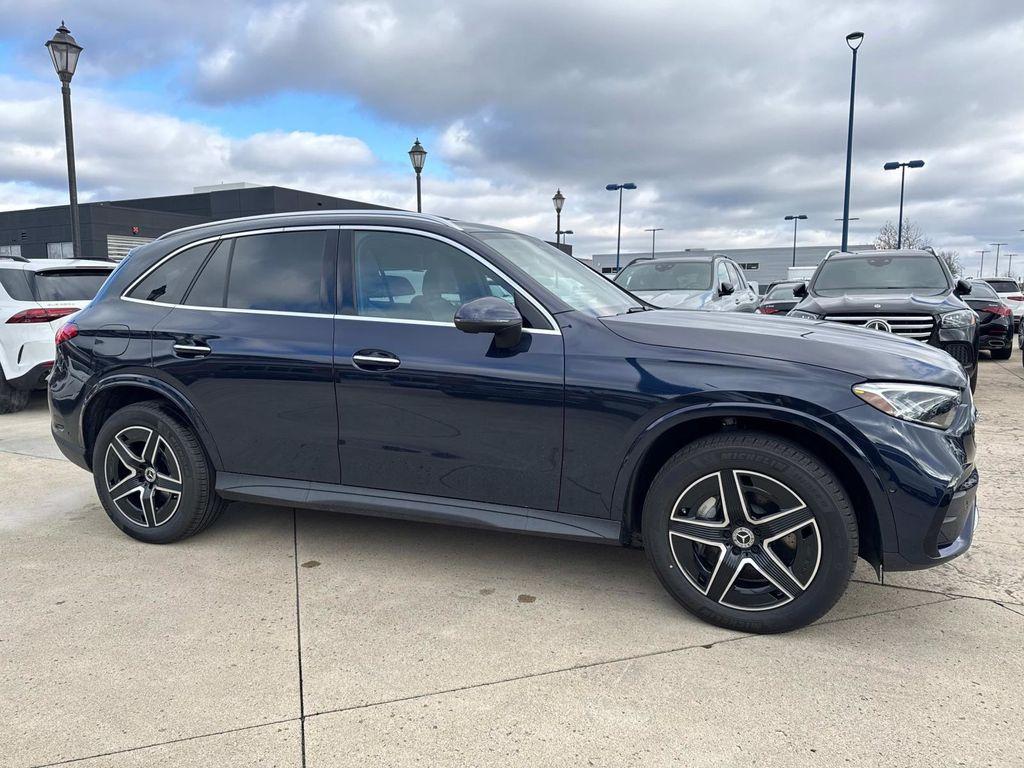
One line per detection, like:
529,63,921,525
92,401,227,544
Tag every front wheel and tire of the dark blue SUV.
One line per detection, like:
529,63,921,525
643,432,858,633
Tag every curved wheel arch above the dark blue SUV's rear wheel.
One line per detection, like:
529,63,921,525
80,374,223,470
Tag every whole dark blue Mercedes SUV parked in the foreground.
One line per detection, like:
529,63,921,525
49,211,978,632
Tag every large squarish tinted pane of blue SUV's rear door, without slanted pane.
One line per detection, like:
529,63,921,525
225,230,327,312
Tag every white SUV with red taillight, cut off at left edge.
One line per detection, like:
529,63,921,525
0,257,115,414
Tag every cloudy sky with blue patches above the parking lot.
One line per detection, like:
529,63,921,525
0,0,1024,271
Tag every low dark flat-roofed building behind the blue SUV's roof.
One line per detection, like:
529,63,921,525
0,184,386,259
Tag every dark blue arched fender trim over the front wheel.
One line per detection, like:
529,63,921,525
611,402,896,549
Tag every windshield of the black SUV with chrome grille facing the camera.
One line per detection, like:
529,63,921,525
813,254,949,296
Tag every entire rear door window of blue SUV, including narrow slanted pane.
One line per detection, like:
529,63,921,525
185,230,328,313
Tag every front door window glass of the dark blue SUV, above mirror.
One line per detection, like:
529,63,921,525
353,231,529,326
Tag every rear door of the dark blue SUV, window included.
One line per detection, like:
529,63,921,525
149,227,339,482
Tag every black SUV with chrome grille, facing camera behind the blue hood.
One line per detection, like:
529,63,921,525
790,250,979,390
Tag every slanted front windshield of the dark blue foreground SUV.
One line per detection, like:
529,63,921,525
473,231,639,317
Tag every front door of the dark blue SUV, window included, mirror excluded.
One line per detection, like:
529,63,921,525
335,228,564,510
